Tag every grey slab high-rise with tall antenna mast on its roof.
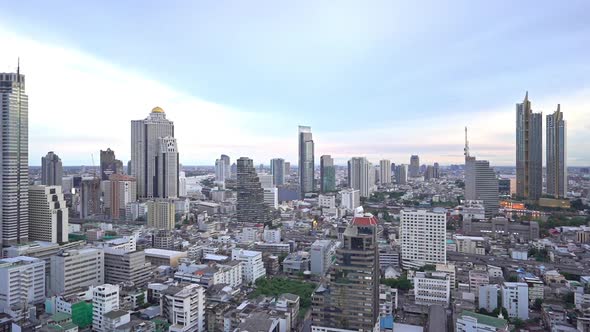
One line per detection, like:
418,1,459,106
464,127,500,218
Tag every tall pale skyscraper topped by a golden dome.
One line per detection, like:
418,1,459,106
131,107,174,198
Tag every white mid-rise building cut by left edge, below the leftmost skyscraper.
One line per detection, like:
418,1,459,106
0,256,45,317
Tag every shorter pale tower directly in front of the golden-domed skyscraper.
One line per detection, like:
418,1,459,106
153,136,180,198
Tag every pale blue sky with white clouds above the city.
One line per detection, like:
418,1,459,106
0,0,590,166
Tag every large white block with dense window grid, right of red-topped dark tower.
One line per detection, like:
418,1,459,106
400,210,447,269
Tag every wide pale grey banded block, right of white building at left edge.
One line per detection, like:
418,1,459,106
49,248,104,296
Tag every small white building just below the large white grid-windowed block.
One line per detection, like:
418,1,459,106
414,272,451,307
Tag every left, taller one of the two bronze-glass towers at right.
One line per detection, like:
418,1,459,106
516,92,543,200
